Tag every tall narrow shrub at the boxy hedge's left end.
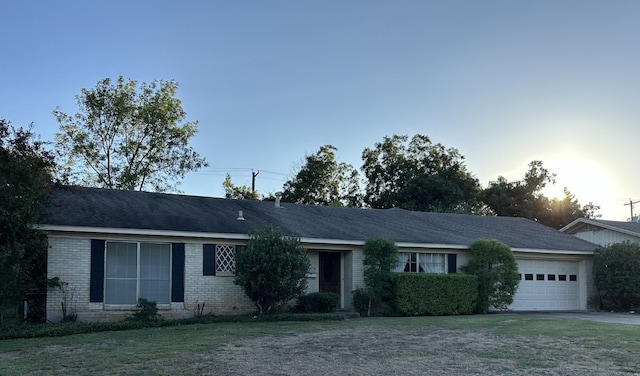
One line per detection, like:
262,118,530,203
362,238,398,316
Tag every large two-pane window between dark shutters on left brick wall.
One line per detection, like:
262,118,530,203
104,242,171,305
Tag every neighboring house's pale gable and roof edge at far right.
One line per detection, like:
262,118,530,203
560,218,640,246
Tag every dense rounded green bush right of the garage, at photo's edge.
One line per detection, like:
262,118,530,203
593,241,640,311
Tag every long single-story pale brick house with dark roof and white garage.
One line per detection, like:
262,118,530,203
40,187,595,321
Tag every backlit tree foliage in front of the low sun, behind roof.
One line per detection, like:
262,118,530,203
482,161,600,229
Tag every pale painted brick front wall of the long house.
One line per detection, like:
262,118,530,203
47,235,350,322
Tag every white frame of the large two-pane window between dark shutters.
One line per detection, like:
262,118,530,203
103,240,173,309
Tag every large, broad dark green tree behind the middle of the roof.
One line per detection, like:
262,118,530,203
362,134,480,213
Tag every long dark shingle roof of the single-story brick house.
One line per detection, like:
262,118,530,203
41,187,595,252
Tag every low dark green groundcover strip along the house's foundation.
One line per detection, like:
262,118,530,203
0,313,344,340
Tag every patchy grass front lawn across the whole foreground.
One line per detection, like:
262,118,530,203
0,314,640,375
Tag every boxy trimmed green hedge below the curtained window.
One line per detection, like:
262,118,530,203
393,273,478,316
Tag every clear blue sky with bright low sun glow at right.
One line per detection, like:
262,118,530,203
0,0,640,221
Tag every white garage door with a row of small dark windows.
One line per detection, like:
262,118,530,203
509,260,580,311
